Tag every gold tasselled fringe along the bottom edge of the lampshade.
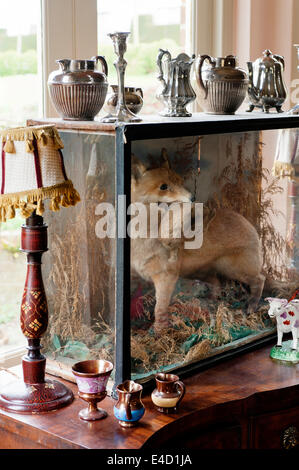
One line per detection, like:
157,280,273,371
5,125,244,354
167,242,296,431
0,180,81,222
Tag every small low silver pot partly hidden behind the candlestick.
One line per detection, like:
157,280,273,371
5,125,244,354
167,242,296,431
103,85,143,115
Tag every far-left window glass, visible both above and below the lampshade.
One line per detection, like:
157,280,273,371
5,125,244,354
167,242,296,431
0,0,42,354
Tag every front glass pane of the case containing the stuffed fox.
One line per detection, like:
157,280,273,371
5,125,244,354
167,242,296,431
131,130,299,380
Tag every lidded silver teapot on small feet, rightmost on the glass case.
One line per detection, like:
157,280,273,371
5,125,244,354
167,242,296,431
247,49,287,113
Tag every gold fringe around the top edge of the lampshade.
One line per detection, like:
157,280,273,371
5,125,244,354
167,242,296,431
0,125,63,153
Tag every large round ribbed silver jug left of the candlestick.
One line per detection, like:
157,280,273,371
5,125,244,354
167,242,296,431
48,56,108,121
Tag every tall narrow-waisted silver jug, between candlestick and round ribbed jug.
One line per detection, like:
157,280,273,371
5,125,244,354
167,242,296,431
157,49,196,117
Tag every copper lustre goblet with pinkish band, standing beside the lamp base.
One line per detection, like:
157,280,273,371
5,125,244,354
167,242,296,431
72,359,113,421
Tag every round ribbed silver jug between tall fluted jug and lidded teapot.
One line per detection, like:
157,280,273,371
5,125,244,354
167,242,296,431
195,54,248,114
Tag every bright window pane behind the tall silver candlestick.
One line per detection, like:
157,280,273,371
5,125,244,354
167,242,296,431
98,0,187,114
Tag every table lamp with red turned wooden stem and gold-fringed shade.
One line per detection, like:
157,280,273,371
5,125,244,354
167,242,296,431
0,125,80,413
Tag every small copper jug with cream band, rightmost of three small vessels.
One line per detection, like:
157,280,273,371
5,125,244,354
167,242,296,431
152,373,186,414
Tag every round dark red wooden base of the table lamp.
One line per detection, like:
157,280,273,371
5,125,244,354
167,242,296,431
0,380,74,413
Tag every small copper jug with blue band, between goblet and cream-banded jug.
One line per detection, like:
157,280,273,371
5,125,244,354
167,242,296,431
114,380,145,428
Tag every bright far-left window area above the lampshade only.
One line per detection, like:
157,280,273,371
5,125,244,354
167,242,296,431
0,0,42,127
